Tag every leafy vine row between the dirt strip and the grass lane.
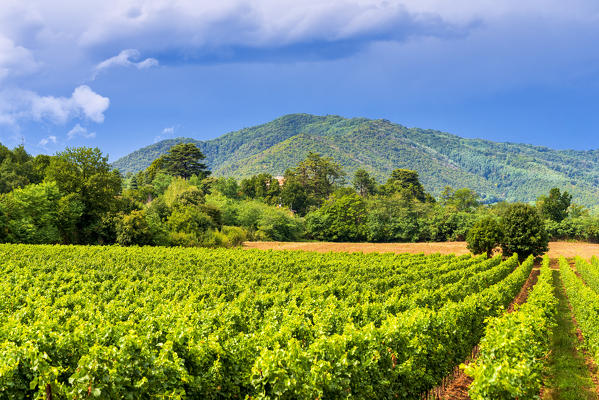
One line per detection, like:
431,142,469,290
465,257,557,400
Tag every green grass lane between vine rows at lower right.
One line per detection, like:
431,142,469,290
543,270,597,400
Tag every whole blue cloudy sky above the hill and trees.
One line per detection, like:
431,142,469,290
0,0,599,161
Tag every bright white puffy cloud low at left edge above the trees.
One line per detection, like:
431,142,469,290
0,85,110,124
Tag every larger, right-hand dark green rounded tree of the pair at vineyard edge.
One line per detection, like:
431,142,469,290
501,203,549,260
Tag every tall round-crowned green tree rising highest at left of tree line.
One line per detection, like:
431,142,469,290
46,147,122,244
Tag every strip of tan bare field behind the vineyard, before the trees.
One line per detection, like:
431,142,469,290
243,242,599,259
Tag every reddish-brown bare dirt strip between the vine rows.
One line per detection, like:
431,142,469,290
427,265,540,400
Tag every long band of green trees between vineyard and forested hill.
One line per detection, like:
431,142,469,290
0,143,599,258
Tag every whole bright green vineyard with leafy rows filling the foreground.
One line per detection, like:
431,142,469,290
0,245,599,399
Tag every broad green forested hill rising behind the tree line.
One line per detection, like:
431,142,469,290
113,114,599,206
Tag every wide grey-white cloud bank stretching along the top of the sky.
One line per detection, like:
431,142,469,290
0,0,599,69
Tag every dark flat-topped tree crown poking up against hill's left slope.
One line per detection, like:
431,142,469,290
154,143,210,179
